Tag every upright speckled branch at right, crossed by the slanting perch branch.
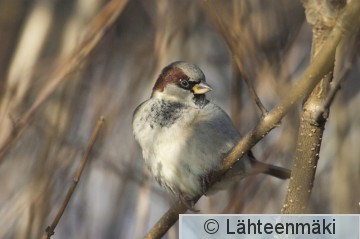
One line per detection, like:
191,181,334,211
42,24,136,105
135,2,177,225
282,0,345,213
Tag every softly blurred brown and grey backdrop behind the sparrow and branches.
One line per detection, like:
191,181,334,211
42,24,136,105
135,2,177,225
0,0,360,239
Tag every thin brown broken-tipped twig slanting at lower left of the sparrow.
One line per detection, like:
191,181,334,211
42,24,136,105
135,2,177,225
42,116,105,239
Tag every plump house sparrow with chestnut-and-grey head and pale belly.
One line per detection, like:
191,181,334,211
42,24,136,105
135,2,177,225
132,61,290,200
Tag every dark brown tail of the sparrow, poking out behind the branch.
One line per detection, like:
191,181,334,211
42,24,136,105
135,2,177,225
248,151,291,179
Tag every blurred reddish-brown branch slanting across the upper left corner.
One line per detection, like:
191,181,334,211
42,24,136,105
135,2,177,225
0,0,128,164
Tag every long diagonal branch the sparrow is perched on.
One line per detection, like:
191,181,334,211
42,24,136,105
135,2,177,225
146,1,360,238
